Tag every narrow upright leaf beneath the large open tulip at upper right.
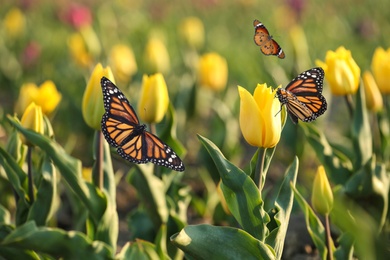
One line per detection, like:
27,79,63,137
351,83,372,169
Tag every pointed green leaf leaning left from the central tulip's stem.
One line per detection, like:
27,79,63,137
199,136,267,240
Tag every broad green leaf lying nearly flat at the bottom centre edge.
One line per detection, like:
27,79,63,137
171,224,275,260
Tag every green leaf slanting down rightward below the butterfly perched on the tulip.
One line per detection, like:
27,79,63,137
299,124,352,184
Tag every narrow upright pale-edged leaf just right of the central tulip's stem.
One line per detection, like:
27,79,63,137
266,157,299,259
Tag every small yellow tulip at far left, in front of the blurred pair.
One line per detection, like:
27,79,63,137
21,102,44,146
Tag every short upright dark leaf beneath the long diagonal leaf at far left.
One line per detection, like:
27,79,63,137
27,157,57,226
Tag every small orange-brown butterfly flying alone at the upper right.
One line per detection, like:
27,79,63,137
253,20,286,59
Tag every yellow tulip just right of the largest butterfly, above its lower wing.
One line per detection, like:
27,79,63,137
138,73,169,123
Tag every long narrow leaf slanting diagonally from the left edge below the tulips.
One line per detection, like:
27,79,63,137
8,116,106,223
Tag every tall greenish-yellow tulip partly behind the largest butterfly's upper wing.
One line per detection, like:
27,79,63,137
82,63,115,130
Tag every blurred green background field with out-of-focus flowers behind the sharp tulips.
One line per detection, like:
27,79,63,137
0,0,390,255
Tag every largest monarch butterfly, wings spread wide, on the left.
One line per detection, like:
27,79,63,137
100,77,184,171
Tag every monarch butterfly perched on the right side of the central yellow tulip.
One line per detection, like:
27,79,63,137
276,68,327,124
